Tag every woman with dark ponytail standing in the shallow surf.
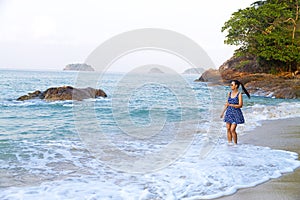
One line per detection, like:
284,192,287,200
221,80,250,145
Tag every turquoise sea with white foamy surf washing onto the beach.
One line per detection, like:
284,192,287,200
0,70,300,199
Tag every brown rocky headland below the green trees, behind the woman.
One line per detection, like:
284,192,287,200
195,57,300,99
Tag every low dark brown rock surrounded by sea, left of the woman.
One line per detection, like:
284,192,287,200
17,86,107,101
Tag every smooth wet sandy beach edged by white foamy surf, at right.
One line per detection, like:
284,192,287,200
218,118,300,200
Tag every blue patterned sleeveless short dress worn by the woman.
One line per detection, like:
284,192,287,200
224,92,245,124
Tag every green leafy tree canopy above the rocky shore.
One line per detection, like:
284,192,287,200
222,0,300,71
